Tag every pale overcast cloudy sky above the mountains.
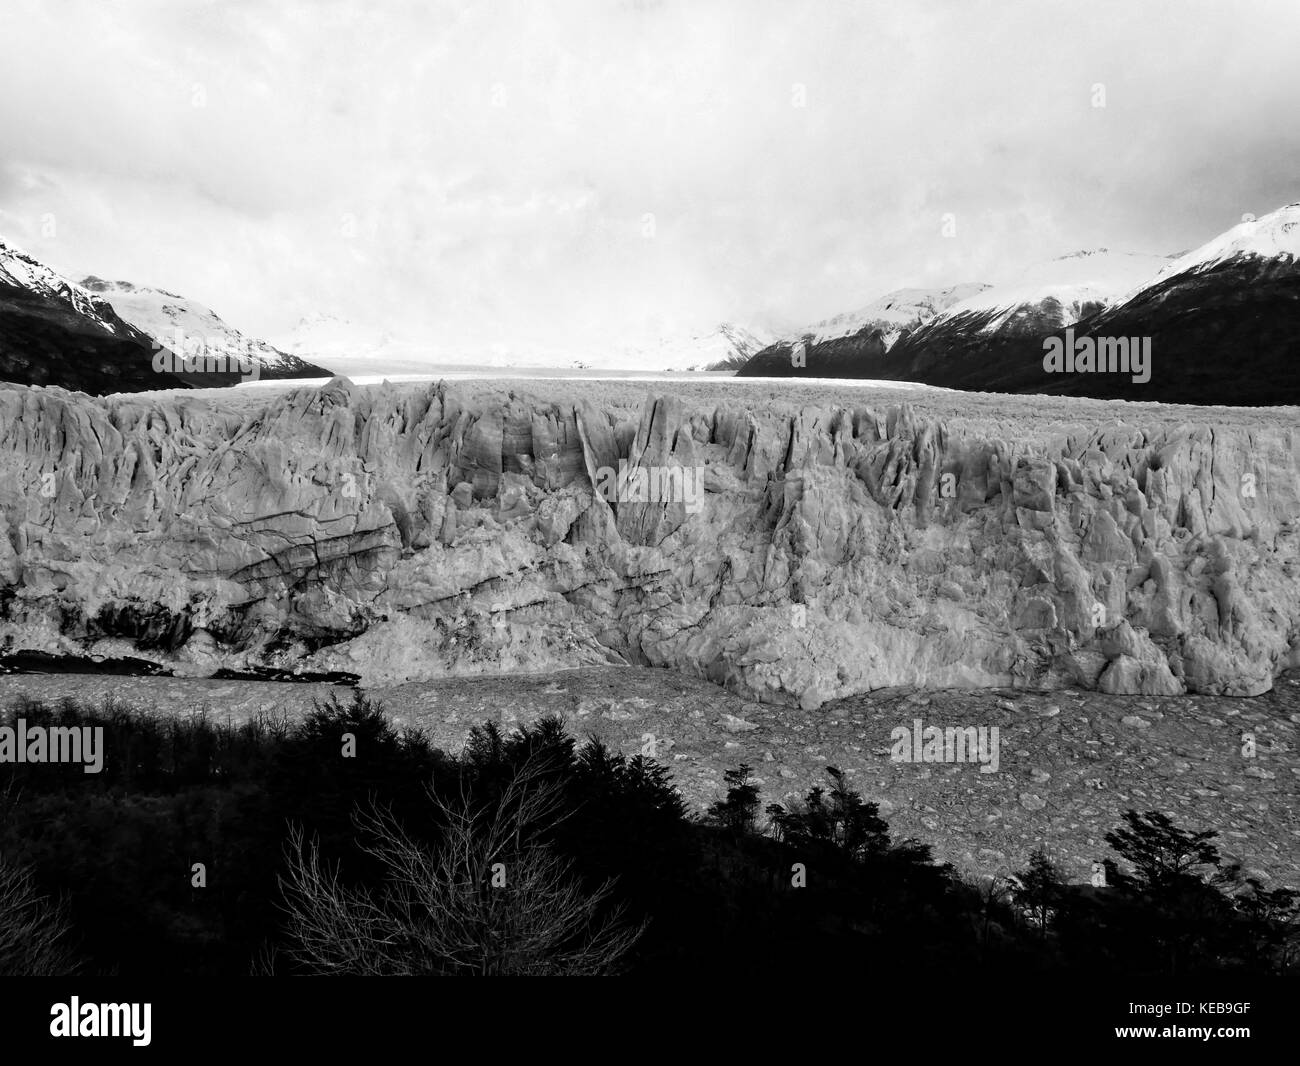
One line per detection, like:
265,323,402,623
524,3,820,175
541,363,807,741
0,0,1300,356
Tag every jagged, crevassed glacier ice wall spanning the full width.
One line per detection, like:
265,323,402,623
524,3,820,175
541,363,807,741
0,378,1300,707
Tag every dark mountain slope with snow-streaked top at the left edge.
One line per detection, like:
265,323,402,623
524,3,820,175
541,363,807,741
0,238,197,394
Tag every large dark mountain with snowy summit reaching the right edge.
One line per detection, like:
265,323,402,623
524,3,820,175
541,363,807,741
863,204,1300,406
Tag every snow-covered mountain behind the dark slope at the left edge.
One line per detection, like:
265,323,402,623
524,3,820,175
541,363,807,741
81,277,332,378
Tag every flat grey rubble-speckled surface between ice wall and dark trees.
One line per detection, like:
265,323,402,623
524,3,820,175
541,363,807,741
0,667,1300,887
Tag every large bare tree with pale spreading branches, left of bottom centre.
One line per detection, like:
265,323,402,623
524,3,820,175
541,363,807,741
281,755,645,975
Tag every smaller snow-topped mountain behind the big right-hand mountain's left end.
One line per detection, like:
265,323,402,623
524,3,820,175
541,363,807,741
737,282,988,378
